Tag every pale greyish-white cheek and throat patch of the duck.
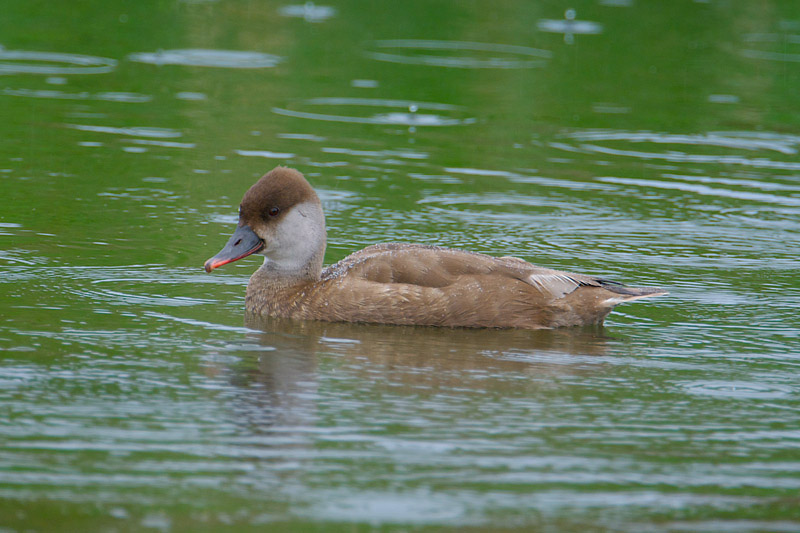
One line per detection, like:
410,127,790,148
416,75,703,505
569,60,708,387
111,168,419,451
260,198,326,277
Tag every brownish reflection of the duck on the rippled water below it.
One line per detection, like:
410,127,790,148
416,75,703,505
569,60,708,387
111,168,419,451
228,315,610,428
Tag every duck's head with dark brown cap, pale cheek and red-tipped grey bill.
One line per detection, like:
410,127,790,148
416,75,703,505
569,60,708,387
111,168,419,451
205,167,326,278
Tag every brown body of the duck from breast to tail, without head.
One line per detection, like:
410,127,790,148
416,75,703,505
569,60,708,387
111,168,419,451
248,243,664,329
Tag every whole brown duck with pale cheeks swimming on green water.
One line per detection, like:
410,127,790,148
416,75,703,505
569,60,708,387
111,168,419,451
204,166,667,330
